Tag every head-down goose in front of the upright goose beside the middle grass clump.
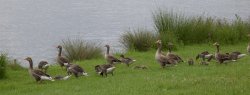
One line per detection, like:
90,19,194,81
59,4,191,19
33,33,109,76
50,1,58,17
95,64,115,77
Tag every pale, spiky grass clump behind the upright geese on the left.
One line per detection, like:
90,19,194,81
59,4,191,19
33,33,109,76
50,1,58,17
62,39,102,61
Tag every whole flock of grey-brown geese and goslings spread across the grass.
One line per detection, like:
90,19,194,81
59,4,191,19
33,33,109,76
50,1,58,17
24,40,250,82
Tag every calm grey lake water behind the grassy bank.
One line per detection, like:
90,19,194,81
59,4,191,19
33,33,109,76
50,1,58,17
0,0,250,66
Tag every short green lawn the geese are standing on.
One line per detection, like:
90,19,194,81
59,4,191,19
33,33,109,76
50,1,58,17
0,43,250,95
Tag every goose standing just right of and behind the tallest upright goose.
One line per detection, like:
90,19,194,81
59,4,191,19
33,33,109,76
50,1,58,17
166,42,184,63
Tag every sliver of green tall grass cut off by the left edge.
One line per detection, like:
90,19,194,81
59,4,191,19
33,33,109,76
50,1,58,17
0,53,8,79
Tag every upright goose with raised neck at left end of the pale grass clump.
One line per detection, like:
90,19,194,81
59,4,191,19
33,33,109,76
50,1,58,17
57,45,69,68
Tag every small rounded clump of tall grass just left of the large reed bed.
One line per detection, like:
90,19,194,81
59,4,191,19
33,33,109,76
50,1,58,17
120,29,157,51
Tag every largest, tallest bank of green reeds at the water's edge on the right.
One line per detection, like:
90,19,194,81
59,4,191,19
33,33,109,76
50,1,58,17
153,10,250,44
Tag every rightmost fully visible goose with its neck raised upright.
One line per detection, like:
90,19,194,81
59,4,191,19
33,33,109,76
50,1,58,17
213,42,231,64
